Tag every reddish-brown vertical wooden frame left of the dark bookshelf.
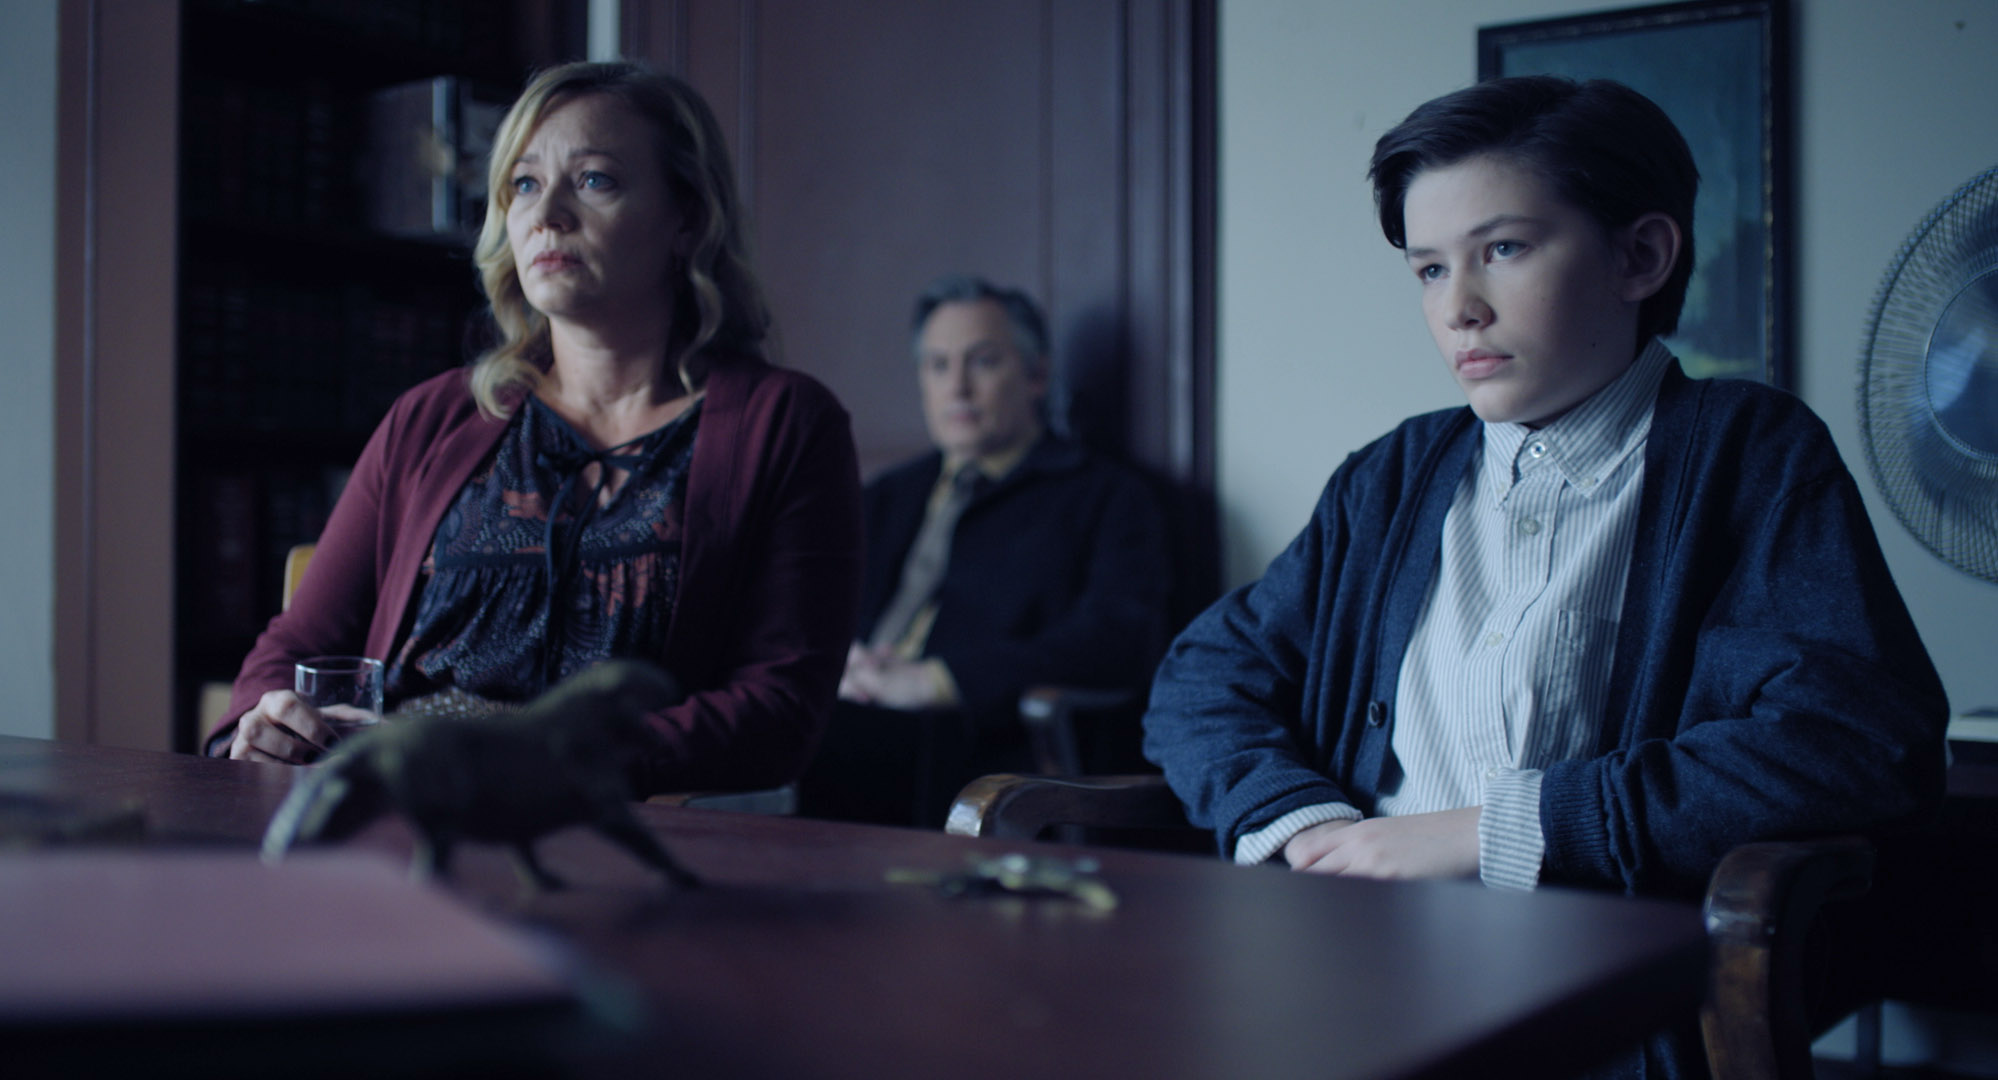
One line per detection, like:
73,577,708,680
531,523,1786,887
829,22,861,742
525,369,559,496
54,0,180,751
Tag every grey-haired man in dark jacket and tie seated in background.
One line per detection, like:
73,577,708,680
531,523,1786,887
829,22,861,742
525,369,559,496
801,275,1171,824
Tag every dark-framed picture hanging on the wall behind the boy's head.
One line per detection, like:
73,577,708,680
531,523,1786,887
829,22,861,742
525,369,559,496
1479,0,1790,385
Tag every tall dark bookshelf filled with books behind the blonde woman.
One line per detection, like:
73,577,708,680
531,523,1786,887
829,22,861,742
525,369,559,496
174,0,583,749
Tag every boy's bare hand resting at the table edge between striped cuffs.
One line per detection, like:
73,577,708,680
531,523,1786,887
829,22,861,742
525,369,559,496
1283,807,1483,878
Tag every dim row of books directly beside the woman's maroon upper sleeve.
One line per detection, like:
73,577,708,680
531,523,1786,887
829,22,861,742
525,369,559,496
188,465,350,641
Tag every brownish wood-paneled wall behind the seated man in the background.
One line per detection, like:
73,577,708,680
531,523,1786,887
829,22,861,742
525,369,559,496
621,0,1215,603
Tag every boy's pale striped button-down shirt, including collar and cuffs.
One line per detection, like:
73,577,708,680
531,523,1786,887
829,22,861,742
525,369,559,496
1235,341,1670,888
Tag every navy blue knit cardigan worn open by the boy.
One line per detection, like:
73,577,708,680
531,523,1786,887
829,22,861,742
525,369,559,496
1145,363,1948,896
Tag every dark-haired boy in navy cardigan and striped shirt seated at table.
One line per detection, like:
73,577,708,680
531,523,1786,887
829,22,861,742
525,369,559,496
1145,76,1948,896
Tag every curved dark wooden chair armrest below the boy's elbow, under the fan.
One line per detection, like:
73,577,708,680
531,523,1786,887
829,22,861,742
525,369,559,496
1700,836,1874,1080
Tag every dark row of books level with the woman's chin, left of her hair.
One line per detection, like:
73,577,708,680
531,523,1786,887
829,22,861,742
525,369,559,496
180,268,464,437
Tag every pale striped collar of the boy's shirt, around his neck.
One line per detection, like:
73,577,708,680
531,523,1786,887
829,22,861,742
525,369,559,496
1485,337,1672,501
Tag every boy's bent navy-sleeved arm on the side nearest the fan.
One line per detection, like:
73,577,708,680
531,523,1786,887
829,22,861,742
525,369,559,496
1540,471,1948,894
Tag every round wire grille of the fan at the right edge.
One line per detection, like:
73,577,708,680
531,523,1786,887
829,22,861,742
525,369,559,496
1860,168,1998,581
